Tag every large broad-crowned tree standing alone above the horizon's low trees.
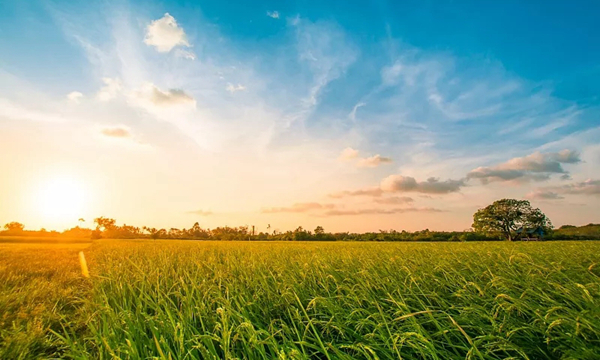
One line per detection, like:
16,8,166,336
472,199,552,240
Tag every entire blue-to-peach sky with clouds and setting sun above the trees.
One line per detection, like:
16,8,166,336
0,0,600,232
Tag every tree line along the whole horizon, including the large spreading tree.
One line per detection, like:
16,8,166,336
0,199,600,241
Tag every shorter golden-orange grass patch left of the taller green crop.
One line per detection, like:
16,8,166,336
0,244,91,359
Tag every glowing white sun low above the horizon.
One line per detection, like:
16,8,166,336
35,176,87,222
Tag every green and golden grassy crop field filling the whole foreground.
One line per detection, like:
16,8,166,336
0,240,600,359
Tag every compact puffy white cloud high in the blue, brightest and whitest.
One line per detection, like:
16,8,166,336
144,13,191,52
